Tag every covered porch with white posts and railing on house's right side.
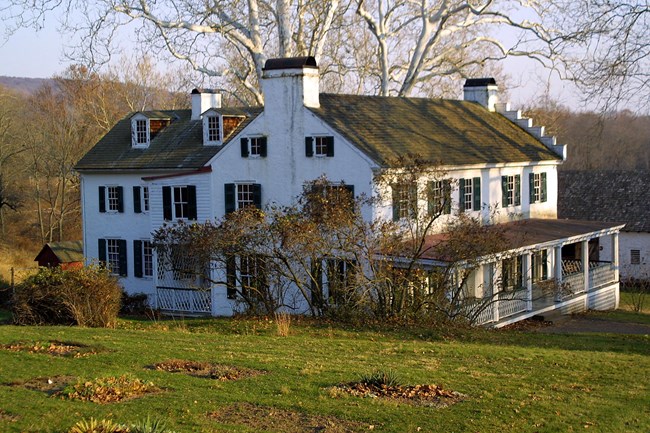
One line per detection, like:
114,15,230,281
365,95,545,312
469,219,623,328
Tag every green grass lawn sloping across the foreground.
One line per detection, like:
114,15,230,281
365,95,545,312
0,313,650,433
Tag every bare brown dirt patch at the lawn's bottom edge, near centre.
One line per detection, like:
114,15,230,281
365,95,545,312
208,403,374,433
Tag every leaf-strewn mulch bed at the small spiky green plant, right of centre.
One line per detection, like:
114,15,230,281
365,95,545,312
334,382,466,408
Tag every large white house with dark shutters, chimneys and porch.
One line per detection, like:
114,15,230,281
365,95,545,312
76,57,622,326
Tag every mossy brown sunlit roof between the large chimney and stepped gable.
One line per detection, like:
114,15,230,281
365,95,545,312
310,94,561,166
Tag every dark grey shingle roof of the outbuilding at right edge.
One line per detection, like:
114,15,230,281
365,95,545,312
557,170,650,232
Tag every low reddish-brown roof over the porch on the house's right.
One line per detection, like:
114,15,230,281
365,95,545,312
421,218,625,261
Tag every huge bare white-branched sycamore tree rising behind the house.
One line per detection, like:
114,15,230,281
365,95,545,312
0,0,552,104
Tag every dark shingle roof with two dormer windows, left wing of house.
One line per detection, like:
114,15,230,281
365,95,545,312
75,107,262,170
